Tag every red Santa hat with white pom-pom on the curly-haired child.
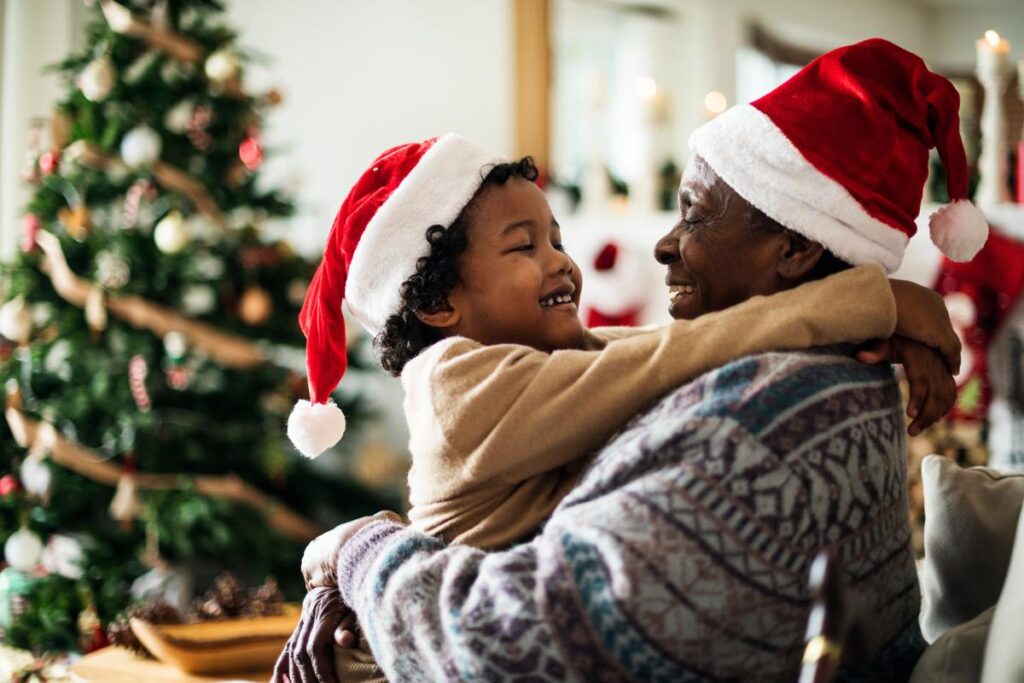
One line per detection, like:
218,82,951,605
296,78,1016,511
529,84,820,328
288,134,504,458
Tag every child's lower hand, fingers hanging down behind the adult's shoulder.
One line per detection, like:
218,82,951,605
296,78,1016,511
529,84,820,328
857,337,956,436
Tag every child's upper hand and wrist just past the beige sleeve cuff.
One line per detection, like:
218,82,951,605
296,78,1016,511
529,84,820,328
889,280,961,375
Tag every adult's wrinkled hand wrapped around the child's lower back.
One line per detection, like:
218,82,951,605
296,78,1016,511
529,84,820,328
271,512,402,683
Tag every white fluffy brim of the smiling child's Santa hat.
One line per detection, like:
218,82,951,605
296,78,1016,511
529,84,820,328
345,133,505,335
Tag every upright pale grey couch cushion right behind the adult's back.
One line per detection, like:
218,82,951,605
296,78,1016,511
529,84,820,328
921,456,1024,642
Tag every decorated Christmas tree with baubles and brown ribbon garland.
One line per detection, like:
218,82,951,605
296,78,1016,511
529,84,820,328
0,0,395,650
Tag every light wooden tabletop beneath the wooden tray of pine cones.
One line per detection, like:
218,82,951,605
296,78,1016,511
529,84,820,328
72,647,272,683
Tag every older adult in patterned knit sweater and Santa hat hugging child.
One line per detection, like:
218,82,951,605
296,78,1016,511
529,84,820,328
275,41,984,683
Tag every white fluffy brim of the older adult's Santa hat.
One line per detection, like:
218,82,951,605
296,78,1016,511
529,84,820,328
690,104,909,272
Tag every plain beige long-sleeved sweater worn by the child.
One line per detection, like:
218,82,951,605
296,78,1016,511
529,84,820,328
401,266,896,549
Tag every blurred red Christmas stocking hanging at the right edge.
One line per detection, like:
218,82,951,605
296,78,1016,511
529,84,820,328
934,230,1024,421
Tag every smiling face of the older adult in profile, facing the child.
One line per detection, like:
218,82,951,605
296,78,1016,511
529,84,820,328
654,156,822,319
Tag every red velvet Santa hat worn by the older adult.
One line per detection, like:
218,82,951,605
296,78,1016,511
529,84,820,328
690,39,988,272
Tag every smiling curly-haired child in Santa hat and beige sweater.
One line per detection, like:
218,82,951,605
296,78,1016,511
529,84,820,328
289,135,957,681
